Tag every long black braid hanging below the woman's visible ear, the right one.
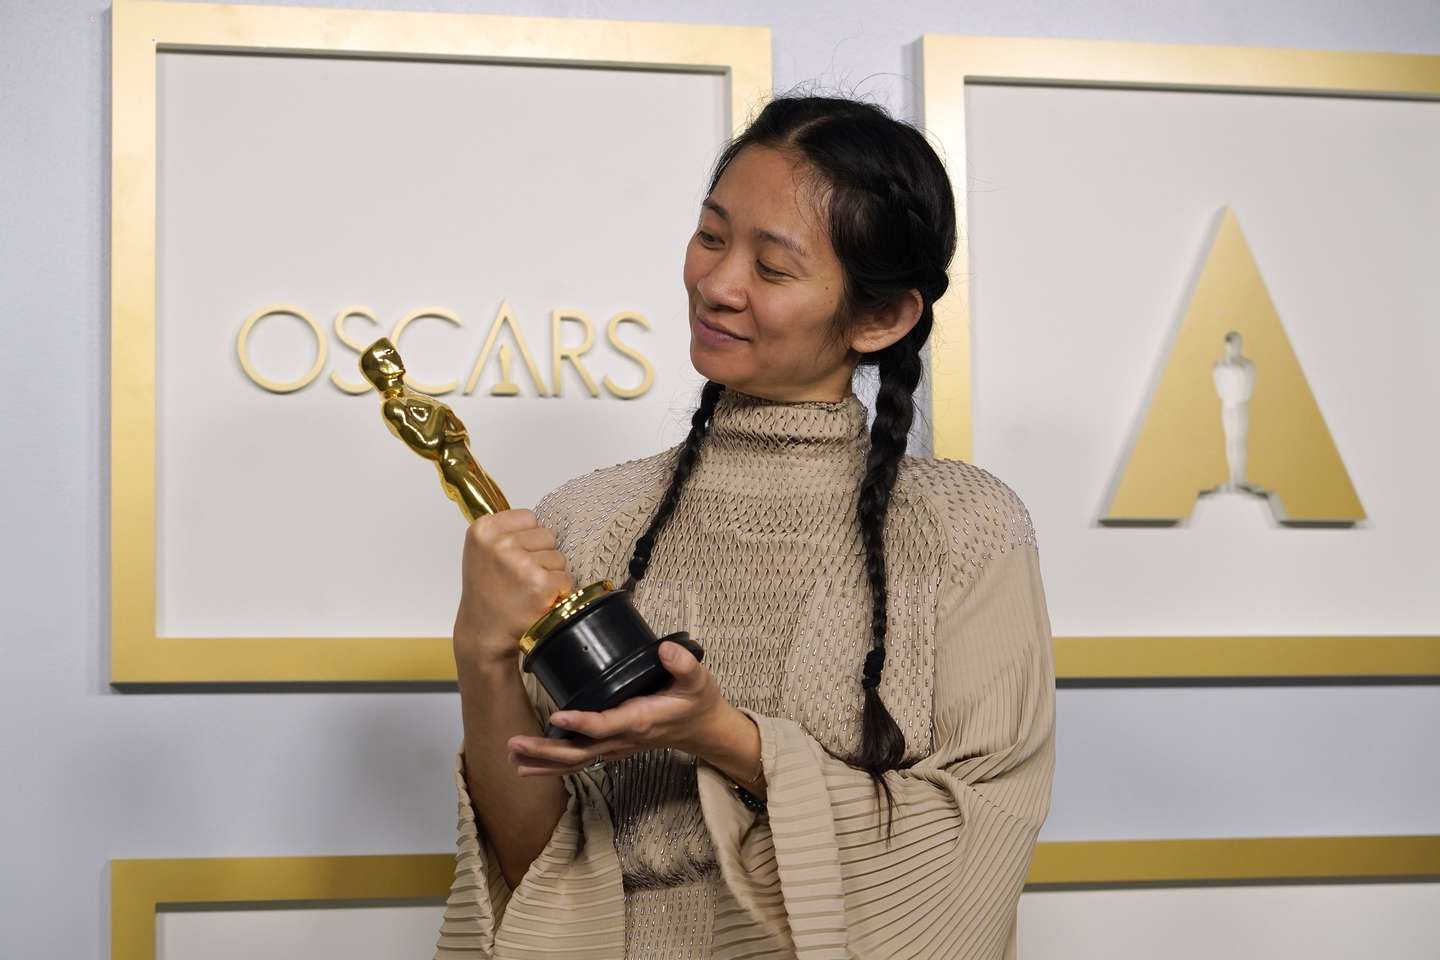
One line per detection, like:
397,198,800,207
851,328,930,822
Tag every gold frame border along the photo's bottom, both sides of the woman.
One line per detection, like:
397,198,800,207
109,835,1440,960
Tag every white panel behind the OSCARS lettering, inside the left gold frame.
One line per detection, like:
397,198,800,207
153,53,729,636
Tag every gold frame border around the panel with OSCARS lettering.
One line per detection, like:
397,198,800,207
109,0,772,684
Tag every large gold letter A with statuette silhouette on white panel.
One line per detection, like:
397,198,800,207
1100,207,1365,525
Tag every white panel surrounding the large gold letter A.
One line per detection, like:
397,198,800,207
965,85,1440,636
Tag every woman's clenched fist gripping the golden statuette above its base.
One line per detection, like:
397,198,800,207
455,510,575,671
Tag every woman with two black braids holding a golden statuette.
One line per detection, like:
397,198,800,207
436,98,1054,960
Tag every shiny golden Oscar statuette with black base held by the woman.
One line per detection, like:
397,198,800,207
360,337,704,737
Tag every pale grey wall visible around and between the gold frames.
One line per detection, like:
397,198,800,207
0,0,1440,959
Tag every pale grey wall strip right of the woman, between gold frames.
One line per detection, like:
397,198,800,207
1040,685,1440,842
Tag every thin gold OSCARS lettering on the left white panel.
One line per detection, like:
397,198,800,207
235,301,655,400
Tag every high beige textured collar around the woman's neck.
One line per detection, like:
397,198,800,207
696,389,870,492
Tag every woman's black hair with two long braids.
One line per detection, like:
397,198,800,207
625,96,956,816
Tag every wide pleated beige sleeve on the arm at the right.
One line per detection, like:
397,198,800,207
700,541,1056,960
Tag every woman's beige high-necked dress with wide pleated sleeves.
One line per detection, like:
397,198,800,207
435,390,1056,960
